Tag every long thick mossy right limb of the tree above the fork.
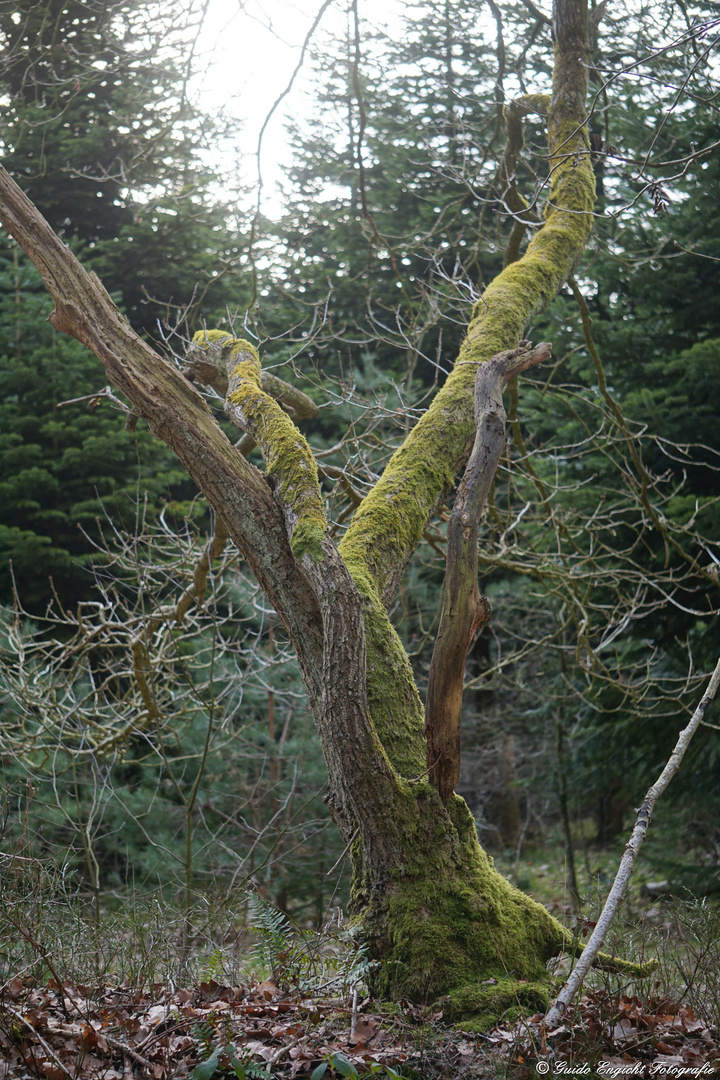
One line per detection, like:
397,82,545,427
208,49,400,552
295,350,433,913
340,27,595,602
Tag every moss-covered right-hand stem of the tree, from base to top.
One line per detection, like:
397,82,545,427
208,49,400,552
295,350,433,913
330,0,595,1022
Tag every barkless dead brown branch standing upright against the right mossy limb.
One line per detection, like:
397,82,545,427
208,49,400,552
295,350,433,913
425,341,552,802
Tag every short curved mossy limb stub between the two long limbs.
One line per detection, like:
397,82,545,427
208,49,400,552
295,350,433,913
193,330,327,563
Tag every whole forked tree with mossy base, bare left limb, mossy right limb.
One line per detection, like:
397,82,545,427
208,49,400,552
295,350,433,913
0,0,634,1017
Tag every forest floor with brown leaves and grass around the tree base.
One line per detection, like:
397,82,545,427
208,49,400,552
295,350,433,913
0,829,720,1080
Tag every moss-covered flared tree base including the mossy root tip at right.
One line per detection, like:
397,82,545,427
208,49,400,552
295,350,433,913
353,783,654,1030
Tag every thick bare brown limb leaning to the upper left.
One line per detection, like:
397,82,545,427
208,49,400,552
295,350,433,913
0,159,322,698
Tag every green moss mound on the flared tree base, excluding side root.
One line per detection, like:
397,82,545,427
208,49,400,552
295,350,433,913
367,783,563,1016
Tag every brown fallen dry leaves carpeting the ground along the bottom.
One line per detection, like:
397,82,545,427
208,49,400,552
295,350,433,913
0,977,720,1080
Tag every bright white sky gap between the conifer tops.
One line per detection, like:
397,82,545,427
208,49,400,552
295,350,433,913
193,0,405,217
